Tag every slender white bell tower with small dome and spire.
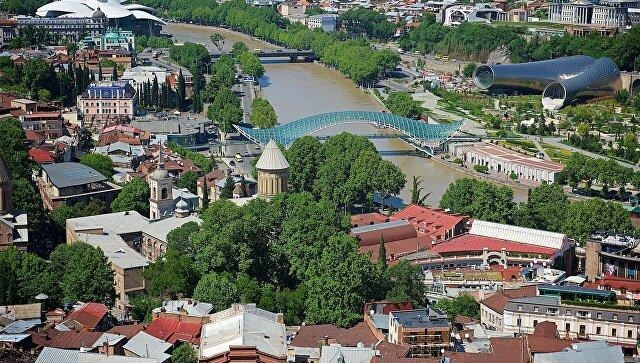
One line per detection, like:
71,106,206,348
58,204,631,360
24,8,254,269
149,144,173,221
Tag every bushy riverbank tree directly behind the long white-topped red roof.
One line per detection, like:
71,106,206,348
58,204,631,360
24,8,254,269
440,178,514,223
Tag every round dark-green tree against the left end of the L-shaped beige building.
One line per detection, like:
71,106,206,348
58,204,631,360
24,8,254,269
49,242,116,306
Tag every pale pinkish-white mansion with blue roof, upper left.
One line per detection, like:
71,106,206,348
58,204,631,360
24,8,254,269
78,82,136,121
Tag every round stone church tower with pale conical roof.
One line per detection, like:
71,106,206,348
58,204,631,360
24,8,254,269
256,140,289,198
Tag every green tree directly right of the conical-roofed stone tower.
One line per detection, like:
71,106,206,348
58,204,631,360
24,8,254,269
284,136,322,192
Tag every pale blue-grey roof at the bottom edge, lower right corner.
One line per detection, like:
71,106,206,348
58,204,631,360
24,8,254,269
535,342,624,363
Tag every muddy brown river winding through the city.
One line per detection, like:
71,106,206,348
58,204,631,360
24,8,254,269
164,23,527,206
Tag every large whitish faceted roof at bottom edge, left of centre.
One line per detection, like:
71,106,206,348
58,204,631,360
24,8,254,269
200,304,287,359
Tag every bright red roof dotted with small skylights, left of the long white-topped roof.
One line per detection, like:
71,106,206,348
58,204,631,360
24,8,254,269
393,204,469,239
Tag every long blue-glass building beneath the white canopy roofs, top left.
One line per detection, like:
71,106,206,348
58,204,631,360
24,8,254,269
13,13,107,42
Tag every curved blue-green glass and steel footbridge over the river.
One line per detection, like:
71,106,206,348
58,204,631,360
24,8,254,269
234,111,462,147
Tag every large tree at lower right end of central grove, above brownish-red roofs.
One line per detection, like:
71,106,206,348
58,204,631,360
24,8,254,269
305,235,373,327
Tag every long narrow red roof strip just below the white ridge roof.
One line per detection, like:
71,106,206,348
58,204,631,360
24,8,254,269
431,233,557,256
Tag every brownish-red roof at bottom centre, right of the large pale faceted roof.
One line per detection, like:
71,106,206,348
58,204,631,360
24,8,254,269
291,322,378,348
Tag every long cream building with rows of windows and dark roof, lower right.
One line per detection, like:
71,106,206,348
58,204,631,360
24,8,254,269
503,285,640,355
